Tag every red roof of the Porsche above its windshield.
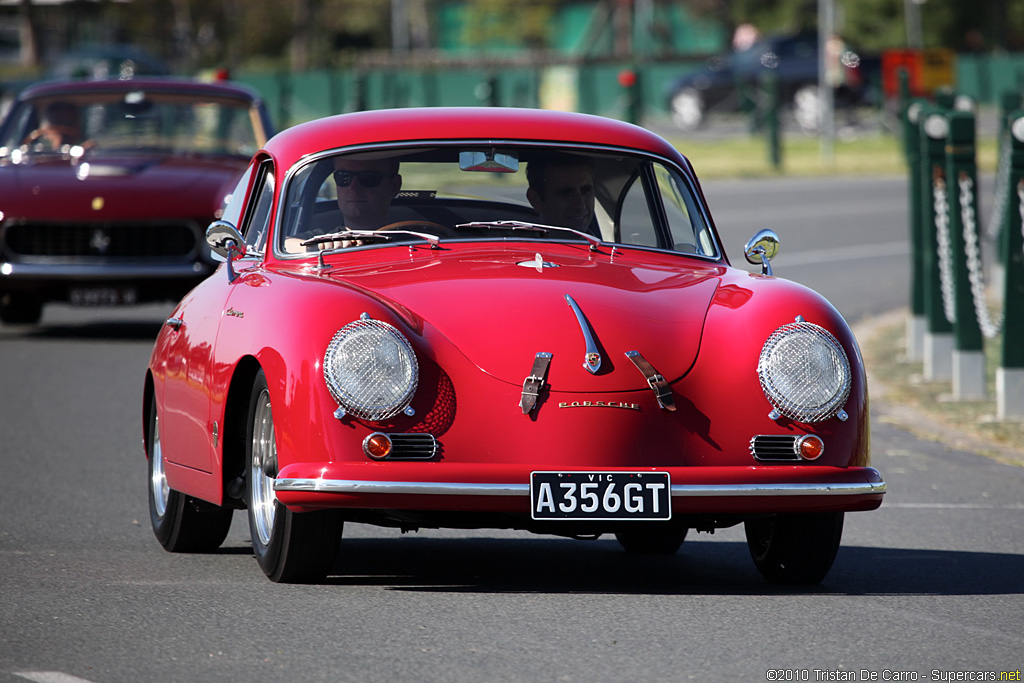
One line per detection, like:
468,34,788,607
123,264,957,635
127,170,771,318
265,106,689,169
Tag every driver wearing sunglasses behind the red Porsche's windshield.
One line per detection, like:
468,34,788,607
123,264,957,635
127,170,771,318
286,157,401,252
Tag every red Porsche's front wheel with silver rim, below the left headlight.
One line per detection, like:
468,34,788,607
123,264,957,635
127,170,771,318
246,370,342,584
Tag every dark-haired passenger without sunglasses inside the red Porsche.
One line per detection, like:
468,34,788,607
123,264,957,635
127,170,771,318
526,154,594,233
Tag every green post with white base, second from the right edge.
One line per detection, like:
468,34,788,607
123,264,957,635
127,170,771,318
946,111,985,399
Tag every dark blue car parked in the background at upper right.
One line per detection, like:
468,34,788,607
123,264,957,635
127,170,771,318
667,33,867,130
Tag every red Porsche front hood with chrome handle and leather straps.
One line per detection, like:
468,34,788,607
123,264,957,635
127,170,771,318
319,245,723,391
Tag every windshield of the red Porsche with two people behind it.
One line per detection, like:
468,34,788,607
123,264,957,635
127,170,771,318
276,144,719,257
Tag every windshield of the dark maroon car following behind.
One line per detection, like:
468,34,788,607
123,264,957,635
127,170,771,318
0,90,259,162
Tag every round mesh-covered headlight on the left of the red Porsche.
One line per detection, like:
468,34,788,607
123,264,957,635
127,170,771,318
324,319,420,422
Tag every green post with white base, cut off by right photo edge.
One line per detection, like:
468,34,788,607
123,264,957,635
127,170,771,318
995,111,1024,420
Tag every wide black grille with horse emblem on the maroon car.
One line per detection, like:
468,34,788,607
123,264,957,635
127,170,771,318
3,221,201,259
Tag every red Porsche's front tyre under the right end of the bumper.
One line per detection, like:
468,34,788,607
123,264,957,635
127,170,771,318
744,512,843,584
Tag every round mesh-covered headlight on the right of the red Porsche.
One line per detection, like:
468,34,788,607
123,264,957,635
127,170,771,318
758,322,851,422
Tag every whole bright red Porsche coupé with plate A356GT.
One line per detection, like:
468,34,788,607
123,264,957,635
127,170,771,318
143,109,886,583
